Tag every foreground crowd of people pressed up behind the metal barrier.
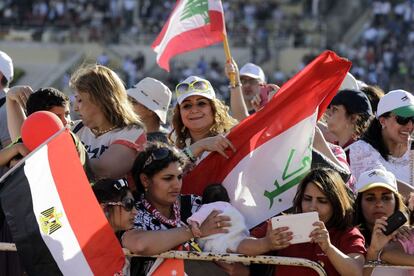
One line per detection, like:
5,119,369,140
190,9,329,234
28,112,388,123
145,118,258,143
0,41,414,275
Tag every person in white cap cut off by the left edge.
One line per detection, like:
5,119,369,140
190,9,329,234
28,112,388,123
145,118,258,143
0,51,13,177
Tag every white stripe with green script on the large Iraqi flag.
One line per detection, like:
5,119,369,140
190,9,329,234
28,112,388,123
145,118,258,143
223,112,317,228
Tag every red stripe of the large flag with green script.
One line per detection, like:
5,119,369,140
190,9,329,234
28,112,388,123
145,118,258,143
182,51,351,195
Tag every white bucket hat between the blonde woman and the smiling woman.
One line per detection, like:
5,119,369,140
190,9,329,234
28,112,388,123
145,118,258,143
127,77,172,124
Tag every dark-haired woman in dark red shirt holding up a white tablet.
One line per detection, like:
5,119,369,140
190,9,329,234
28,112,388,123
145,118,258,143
238,168,366,275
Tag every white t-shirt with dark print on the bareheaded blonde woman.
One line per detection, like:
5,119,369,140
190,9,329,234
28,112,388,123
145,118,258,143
73,121,146,159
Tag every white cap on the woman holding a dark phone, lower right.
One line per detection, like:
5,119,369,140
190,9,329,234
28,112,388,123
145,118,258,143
356,169,398,193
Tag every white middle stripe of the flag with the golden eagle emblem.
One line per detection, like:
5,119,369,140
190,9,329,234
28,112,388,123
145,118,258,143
24,146,93,275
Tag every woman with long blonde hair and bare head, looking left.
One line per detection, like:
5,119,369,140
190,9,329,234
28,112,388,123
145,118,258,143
70,65,146,181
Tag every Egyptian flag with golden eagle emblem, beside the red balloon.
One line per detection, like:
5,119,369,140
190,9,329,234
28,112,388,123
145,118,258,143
0,129,125,276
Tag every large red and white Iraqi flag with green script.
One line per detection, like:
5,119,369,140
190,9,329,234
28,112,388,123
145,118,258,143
182,51,351,228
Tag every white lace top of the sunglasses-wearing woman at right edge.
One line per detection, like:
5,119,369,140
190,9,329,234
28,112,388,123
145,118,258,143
349,140,413,185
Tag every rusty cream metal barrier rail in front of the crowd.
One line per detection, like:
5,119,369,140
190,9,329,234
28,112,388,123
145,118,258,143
0,243,327,276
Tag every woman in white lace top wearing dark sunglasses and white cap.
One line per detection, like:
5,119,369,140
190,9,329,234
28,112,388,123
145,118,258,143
349,90,414,195
